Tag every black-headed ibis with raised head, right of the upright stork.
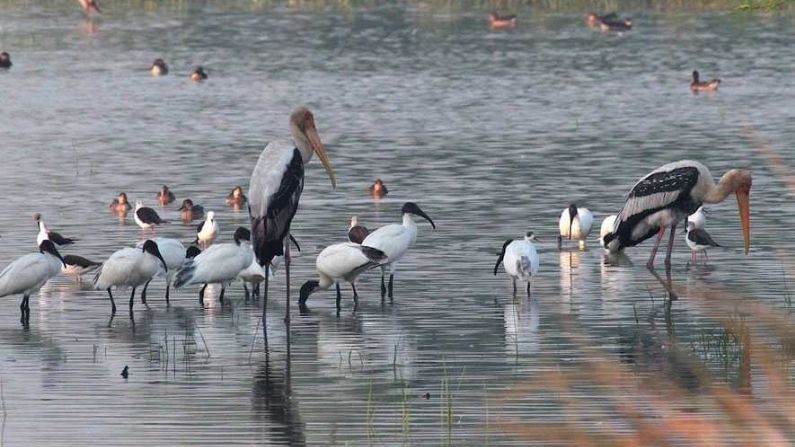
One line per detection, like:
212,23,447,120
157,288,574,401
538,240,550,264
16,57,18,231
362,202,436,298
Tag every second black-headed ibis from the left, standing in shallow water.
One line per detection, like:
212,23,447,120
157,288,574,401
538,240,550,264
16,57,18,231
94,240,168,318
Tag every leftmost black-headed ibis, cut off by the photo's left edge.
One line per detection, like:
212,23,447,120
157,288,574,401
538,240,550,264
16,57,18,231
0,240,64,325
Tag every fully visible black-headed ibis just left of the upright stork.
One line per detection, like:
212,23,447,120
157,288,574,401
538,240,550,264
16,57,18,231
174,227,254,307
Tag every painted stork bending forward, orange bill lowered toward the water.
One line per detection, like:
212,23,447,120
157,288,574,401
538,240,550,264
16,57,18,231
604,160,751,269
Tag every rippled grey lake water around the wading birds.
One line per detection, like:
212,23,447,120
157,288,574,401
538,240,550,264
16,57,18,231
0,2,795,445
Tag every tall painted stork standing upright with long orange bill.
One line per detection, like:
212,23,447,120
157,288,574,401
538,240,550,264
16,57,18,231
248,107,337,327
